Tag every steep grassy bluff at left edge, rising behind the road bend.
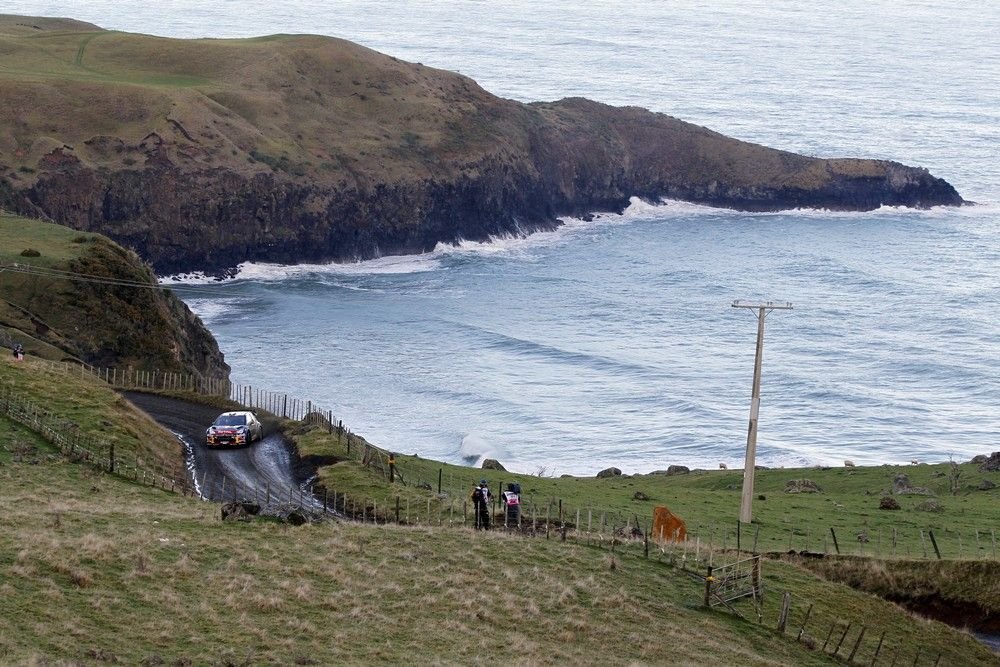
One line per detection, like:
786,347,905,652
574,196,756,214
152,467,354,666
0,213,229,378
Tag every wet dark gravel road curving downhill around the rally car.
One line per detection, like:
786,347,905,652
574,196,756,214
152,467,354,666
125,391,322,511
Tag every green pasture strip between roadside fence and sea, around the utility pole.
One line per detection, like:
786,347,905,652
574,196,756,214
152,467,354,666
294,428,1000,564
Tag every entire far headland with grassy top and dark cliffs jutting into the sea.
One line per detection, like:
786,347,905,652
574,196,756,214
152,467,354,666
0,15,963,273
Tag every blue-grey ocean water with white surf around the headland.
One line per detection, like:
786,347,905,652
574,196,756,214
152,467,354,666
9,0,1000,474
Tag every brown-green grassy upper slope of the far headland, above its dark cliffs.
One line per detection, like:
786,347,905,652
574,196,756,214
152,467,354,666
0,16,523,181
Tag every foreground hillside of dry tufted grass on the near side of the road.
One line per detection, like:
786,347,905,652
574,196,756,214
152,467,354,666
0,359,995,665
